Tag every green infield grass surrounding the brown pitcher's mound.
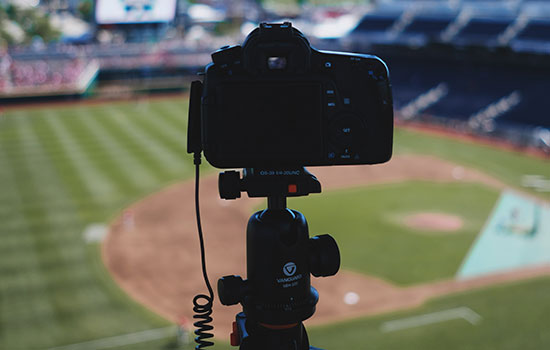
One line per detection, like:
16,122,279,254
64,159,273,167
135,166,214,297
289,182,498,285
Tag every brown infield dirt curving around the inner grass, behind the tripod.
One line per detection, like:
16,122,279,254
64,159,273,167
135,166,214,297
102,155,550,339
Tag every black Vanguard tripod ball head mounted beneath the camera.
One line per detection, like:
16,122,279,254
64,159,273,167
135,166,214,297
218,168,340,350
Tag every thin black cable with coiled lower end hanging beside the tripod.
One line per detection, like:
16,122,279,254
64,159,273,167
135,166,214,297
193,152,214,349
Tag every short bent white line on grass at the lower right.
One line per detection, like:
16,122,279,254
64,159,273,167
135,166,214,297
380,306,482,333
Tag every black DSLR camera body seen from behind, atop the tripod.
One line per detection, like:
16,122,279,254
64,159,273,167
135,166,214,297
196,22,393,169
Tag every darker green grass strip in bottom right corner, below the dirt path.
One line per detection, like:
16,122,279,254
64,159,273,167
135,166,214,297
310,278,550,350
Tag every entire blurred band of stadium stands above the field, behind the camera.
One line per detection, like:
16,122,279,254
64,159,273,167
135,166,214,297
0,0,550,150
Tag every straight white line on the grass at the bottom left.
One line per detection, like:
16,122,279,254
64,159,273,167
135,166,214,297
48,326,176,350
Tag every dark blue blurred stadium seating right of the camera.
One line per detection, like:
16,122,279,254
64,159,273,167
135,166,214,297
341,0,550,147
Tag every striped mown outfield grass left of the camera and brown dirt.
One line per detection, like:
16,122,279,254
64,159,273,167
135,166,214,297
0,99,192,350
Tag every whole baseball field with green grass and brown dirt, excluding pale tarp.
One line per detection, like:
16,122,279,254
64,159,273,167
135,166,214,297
0,96,550,350
